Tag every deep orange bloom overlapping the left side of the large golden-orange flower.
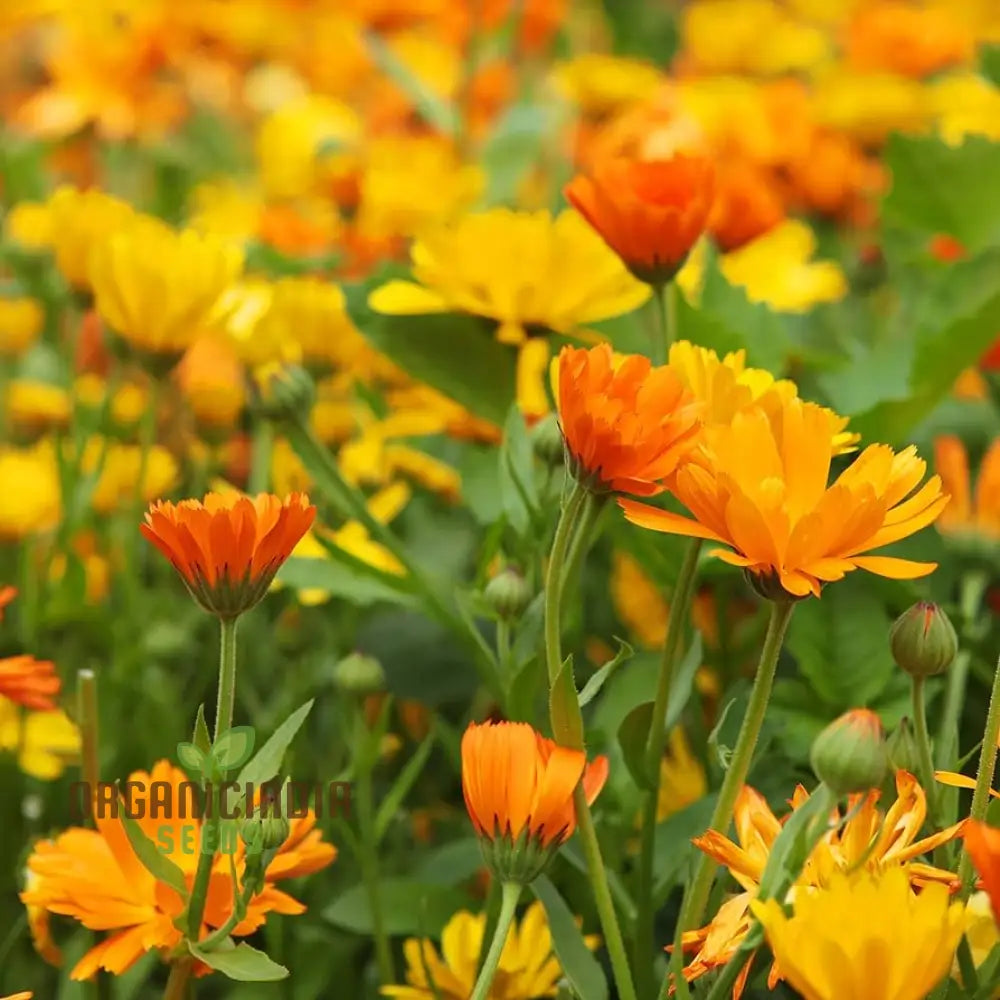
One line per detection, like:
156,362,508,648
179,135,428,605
558,344,701,496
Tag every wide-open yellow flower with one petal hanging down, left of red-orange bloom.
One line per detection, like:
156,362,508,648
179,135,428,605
368,208,650,414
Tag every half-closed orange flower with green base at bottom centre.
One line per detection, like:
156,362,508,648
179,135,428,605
462,722,608,883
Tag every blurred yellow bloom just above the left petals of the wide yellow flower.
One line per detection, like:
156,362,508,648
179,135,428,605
358,136,486,238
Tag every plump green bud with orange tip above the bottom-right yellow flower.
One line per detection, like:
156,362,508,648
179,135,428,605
809,708,889,795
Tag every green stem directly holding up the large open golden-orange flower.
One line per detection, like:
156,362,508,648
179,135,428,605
665,600,795,956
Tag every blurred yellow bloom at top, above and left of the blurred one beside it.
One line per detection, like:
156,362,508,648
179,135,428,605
255,94,361,199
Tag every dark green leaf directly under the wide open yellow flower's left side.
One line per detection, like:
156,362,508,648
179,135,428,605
344,285,517,427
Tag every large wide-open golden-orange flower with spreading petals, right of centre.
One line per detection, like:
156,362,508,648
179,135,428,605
618,398,948,597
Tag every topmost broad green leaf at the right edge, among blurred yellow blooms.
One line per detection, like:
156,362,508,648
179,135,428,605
882,134,1000,254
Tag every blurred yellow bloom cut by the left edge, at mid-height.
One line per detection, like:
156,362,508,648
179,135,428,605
0,440,62,540
